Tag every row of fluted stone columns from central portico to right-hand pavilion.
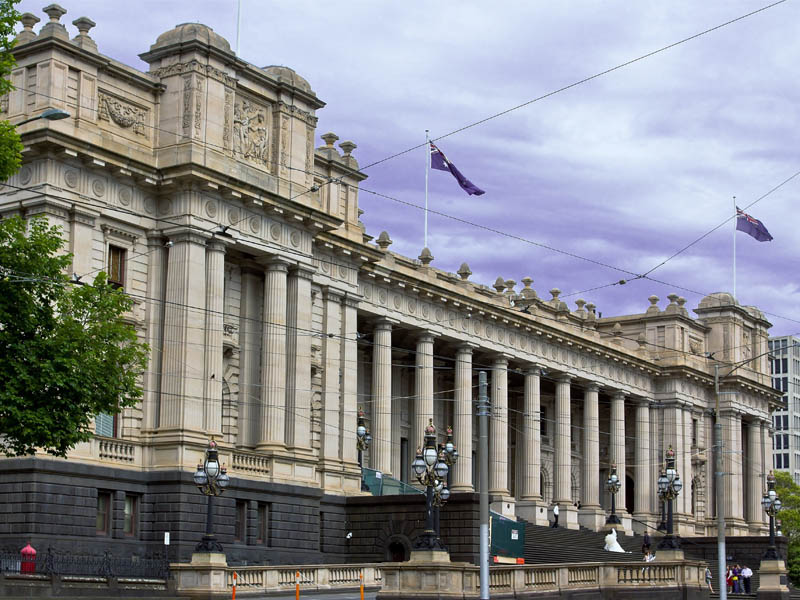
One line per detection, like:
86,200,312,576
370,319,771,531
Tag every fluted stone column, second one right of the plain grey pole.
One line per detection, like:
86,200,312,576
517,366,542,501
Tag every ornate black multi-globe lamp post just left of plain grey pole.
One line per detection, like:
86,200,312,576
411,419,457,552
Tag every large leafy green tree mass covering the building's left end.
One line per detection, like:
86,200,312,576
0,217,147,456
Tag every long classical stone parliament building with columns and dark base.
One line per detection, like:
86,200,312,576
0,5,780,563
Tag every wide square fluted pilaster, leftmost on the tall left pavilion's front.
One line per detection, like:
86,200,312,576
159,230,207,434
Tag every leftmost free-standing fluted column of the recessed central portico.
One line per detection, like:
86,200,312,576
371,319,392,474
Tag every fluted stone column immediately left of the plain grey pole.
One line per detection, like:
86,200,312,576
450,344,474,492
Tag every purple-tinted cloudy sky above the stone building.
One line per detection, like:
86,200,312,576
19,0,800,335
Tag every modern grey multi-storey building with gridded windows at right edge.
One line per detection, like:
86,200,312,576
769,336,800,483
